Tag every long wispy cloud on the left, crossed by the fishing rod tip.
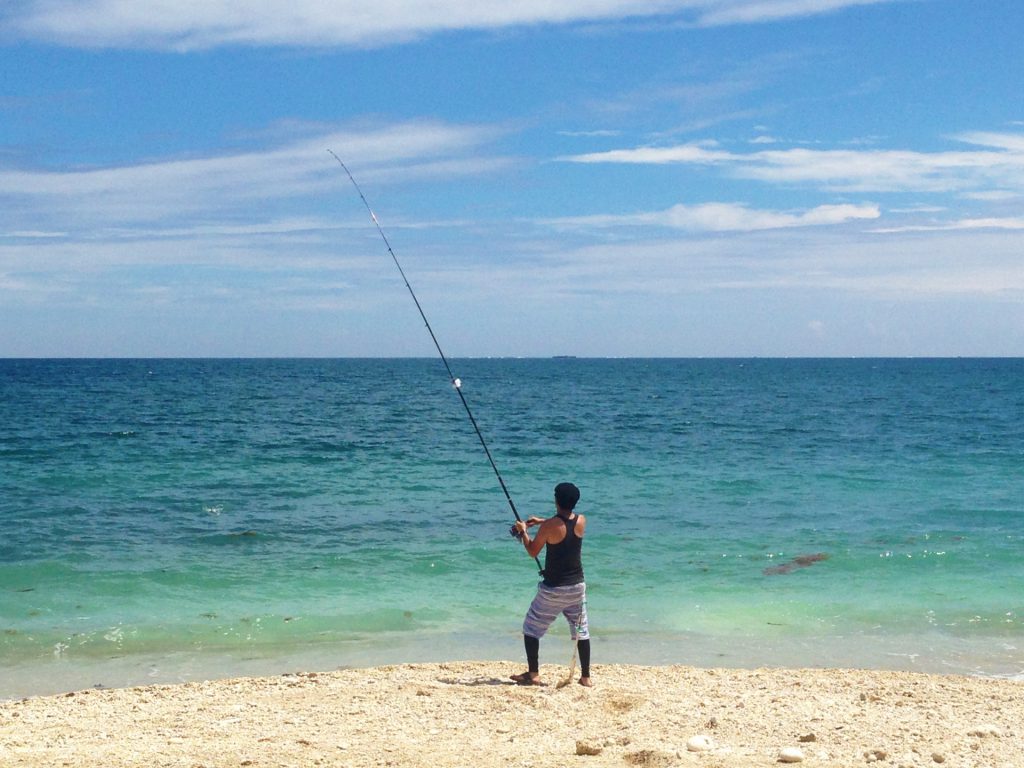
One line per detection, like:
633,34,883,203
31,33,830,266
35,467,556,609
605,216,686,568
0,122,503,228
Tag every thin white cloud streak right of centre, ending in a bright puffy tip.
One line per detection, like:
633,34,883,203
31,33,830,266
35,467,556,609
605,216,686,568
552,203,880,232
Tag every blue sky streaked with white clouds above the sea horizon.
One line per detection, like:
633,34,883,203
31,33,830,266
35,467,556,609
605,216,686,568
0,0,1024,357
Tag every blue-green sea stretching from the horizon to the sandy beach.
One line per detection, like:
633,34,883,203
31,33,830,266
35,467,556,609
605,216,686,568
0,358,1024,697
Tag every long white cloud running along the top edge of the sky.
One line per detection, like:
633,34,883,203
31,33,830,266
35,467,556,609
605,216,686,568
6,0,898,50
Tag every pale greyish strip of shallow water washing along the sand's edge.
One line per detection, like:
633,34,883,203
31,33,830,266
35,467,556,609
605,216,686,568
0,628,1024,701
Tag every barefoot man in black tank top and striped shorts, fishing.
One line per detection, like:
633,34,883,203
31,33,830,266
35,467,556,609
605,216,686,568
512,482,591,688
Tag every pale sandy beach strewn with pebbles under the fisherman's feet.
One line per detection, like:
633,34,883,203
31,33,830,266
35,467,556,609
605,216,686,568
0,662,1024,768
